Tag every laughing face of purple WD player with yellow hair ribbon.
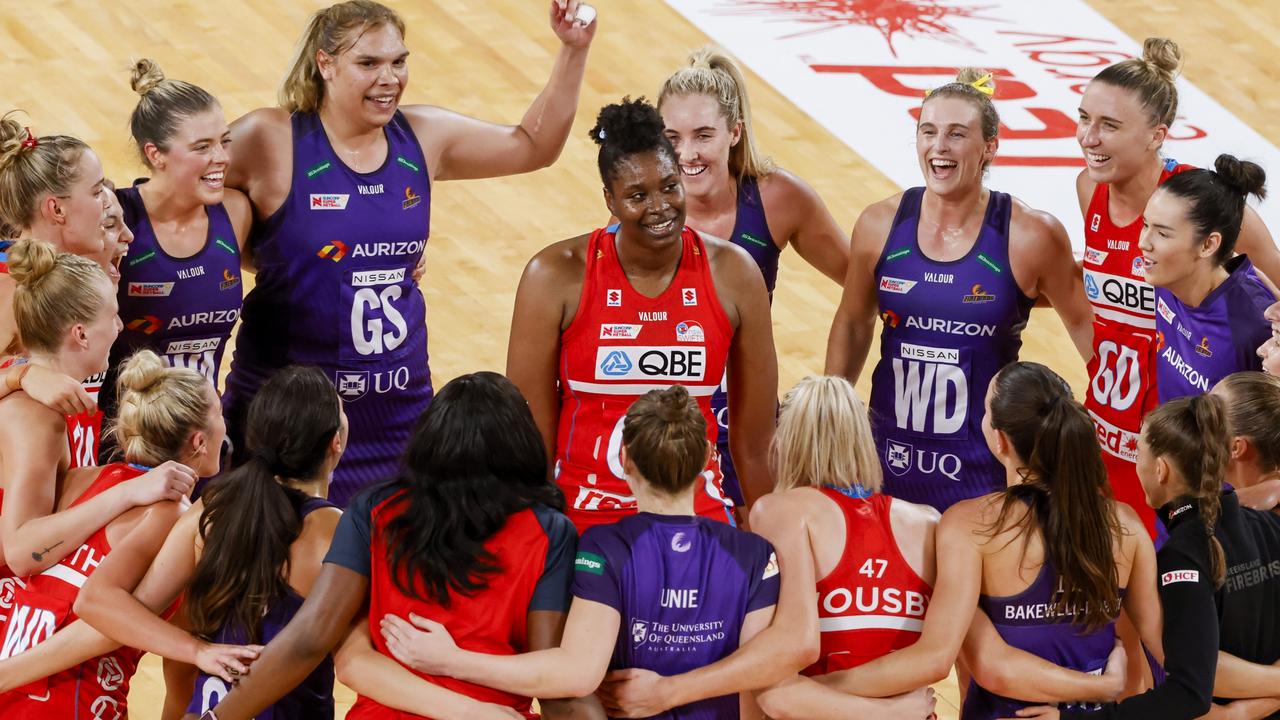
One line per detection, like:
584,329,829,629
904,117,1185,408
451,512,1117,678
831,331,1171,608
915,96,998,196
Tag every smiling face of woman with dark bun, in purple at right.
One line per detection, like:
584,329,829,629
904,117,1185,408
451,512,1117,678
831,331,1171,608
1138,188,1222,288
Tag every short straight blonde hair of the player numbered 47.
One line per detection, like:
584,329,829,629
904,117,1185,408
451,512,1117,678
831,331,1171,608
772,375,884,492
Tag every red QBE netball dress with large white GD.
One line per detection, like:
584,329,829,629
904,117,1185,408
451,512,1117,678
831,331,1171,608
1084,160,1192,462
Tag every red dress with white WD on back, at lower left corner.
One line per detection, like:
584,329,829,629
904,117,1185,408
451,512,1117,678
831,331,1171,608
0,464,143,720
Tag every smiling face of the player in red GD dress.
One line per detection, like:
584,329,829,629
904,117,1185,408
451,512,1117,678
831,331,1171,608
1075,81,1169,183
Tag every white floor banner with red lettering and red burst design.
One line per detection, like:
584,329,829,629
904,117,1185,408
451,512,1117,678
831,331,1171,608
667,0,1280,255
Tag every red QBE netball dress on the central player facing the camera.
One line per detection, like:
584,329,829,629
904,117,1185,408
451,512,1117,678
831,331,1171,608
556,225,733,530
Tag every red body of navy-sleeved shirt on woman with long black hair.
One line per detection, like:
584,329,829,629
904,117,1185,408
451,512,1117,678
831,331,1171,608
347,493,549,720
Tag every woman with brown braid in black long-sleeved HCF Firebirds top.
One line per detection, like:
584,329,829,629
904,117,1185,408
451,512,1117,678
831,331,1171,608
1019,395,1280,720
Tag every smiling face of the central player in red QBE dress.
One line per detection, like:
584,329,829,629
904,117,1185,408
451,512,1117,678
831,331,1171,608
604,150,685,242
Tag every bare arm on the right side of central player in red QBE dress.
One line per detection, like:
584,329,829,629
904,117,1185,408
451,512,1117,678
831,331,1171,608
717,246,778,507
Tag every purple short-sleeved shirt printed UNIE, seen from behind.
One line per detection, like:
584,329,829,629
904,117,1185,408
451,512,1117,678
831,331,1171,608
573,512,780,720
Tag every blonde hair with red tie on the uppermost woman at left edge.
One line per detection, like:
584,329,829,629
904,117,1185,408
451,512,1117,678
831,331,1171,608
0,110,88,229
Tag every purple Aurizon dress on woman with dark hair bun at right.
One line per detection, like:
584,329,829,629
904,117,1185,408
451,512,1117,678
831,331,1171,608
1156,255,1275,402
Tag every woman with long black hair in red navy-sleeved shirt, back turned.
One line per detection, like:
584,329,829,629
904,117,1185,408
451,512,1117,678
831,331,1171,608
185,373,599,720
